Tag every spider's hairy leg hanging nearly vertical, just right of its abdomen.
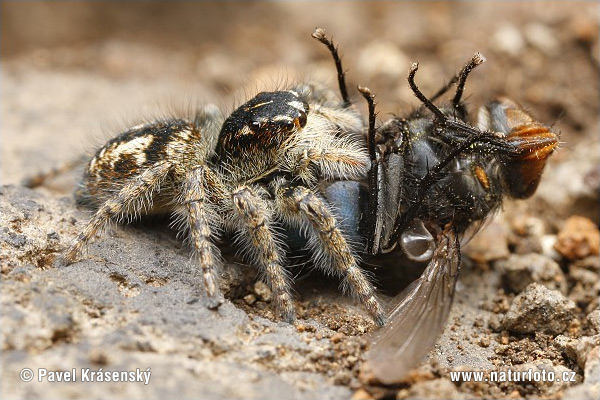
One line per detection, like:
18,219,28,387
181,166,223,309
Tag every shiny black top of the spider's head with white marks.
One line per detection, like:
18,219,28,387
216,90,309,159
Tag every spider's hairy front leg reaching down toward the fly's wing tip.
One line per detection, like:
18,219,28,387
276,186,385,325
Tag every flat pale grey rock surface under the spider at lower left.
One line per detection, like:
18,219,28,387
0,186,360,399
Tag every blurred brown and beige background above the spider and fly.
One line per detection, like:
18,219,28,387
0,1,599,212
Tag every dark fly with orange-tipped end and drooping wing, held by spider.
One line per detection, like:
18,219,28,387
326,50,558,383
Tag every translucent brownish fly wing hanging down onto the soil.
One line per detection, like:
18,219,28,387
367,232,460,384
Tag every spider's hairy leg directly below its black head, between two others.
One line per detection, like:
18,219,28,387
231,186,296,323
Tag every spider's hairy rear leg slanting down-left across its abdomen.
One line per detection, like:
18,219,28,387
58,162,173,265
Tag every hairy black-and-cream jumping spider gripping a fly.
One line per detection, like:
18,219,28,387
61,30,384,325
